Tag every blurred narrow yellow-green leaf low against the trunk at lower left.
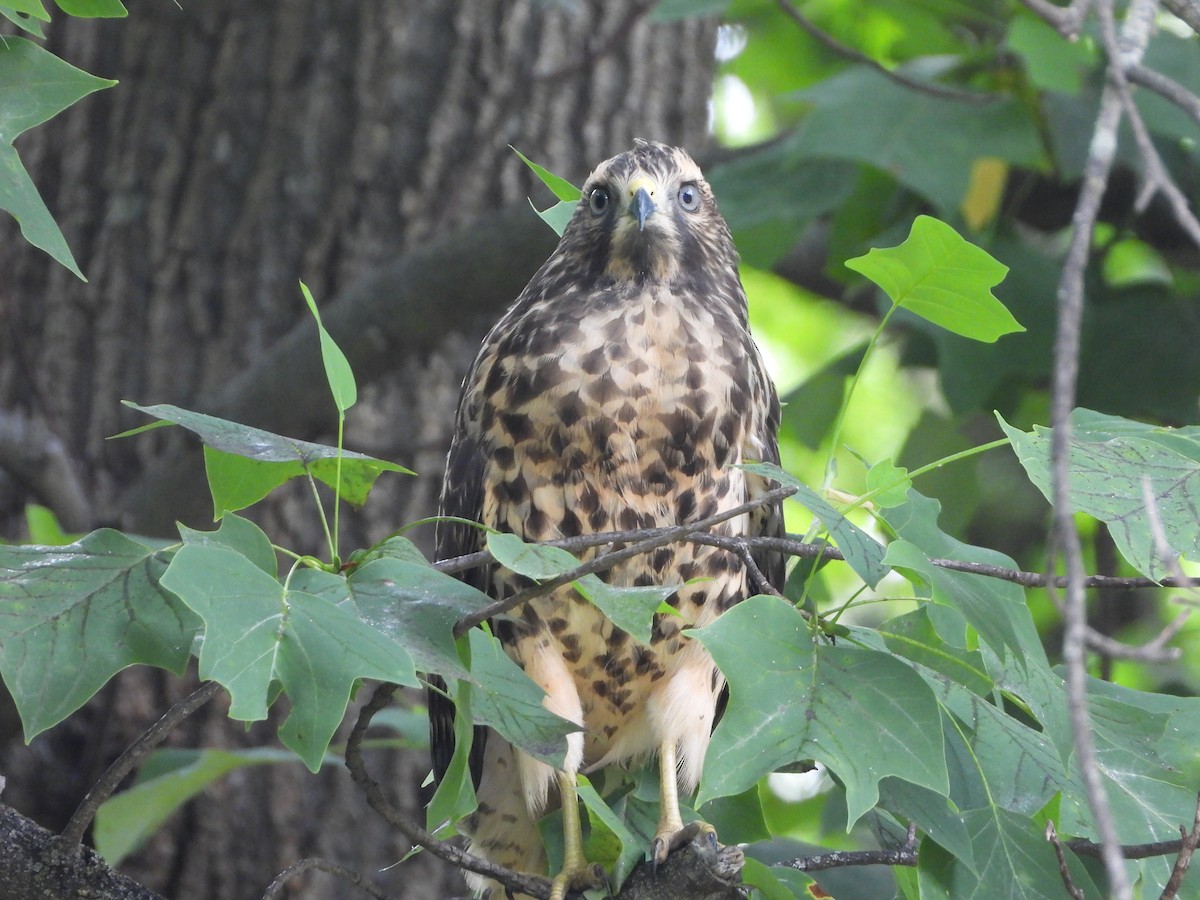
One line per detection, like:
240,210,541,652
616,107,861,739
92,748,296,866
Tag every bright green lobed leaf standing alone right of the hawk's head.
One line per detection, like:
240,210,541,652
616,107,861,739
846,216,1025,343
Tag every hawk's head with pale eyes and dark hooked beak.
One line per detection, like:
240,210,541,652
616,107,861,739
559,140,737,283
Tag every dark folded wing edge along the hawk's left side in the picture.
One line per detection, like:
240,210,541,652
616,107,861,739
426,384,491,787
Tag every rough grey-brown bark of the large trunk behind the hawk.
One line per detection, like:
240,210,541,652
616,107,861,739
0,0,715,900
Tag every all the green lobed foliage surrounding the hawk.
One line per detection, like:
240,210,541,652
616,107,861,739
0,0,1200,898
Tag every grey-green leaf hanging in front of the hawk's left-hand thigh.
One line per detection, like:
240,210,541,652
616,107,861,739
470,629,582,768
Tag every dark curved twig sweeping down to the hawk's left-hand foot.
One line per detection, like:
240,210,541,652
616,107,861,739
346,684,550,900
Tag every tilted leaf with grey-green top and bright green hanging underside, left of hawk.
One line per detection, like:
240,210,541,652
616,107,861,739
116,400,413,518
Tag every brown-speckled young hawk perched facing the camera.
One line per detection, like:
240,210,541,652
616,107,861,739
430,140,784,900
